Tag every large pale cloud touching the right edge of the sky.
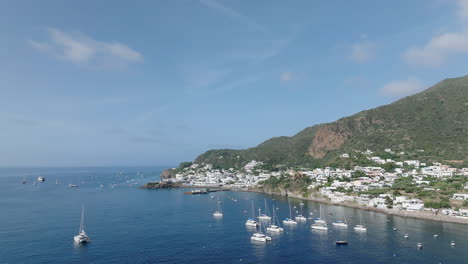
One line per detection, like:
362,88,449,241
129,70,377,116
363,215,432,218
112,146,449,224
403,0,468,67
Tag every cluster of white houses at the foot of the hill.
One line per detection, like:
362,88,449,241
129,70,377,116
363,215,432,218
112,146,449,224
171,157,468,217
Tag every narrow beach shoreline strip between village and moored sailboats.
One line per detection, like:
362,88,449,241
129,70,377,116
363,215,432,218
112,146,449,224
245,189,468,225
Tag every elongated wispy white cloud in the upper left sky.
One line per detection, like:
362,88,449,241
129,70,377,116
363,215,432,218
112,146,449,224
29,28,143,68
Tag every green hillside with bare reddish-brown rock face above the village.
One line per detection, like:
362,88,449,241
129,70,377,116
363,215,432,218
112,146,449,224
194,76,468,168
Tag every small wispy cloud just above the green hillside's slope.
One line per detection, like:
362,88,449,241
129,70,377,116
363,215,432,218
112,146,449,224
380,78,424,98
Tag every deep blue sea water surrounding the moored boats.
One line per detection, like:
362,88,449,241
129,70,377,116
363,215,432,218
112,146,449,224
0,167,468,264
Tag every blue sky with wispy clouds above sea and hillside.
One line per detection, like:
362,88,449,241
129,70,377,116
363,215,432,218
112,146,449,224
0,0,468,167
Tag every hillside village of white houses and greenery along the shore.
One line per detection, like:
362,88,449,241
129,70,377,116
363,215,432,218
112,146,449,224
164,149,468,218
